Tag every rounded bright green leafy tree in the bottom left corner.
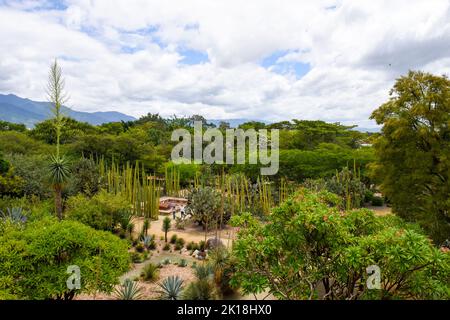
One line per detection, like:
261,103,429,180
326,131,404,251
0,217,129,299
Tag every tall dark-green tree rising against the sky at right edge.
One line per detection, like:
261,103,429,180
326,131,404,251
372,71,450,244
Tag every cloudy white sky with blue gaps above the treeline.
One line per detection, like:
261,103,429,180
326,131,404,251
0,0,450,128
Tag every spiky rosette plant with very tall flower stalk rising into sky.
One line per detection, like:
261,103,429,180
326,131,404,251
47,59,69,219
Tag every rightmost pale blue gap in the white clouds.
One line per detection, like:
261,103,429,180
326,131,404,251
261,50,311,79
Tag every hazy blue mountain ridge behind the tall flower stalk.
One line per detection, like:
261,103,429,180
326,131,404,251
0,94,136,128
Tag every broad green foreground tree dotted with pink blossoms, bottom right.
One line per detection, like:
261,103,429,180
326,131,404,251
232,189,450,300
